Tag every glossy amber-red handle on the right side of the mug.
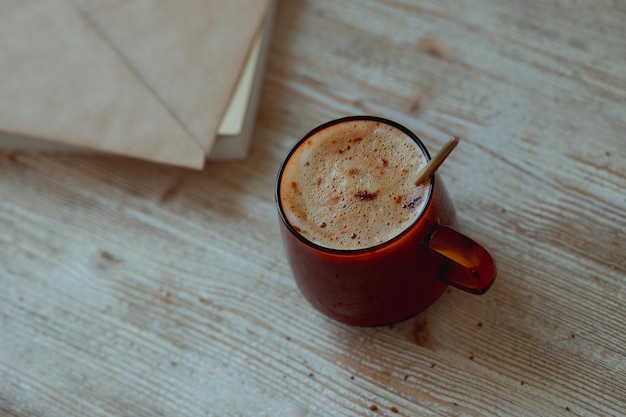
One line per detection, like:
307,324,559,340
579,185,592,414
426,225,496,294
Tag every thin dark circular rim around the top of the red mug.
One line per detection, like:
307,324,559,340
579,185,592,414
274,115,435,255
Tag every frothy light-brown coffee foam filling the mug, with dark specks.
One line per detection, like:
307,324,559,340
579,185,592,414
280,120,430,249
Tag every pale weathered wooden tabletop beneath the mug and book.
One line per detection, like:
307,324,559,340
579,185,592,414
0,0,626,417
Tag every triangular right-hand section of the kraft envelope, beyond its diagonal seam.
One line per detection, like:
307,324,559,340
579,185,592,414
74,0,269,152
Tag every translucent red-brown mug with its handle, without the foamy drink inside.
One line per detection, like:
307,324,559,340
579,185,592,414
275,116,496,326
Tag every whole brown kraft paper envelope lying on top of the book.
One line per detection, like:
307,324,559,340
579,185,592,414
0,0,269,168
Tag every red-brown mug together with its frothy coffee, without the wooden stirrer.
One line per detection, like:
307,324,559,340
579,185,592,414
276,116,496,325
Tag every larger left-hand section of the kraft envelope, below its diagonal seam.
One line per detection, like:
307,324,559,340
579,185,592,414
0,0,205,168
